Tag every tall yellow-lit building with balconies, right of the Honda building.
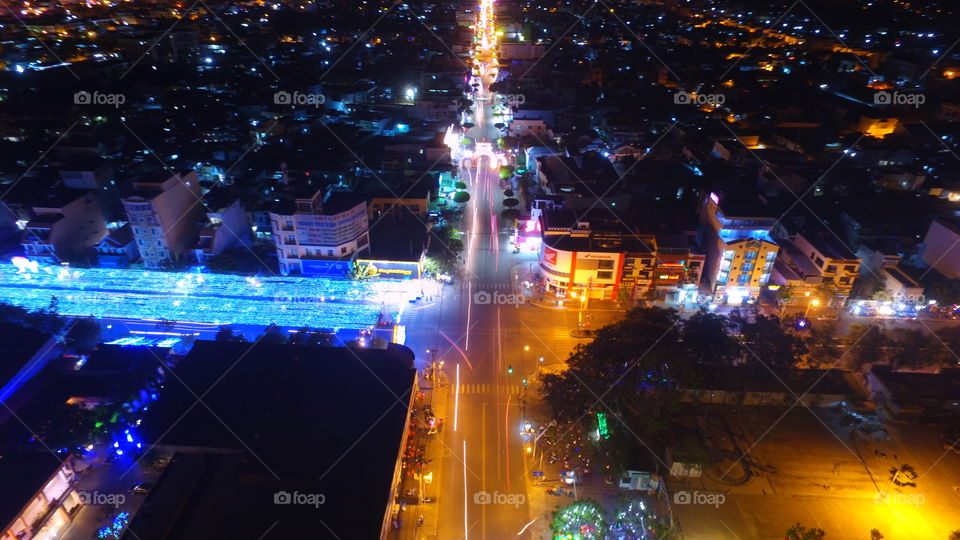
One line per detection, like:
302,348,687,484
698,193,780,305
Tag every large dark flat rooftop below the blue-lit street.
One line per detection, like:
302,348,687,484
133,341,415,540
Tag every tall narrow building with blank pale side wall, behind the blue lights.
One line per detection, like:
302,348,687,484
123,171,204,269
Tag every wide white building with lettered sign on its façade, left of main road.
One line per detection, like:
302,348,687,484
270,190,370,275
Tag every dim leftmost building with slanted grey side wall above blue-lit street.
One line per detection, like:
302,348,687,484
20,190,107,264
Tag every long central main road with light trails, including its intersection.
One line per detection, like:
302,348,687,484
406,20,616,540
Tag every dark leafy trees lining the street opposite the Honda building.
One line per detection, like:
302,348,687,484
542,307,960,472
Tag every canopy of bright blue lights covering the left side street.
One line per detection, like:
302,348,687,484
0,263,419,328
